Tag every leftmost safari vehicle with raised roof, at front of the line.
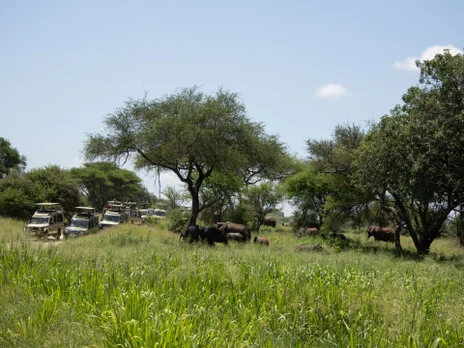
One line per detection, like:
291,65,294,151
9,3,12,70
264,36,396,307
25,203,66,240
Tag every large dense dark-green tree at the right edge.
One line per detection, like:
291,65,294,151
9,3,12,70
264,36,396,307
356,52,464,254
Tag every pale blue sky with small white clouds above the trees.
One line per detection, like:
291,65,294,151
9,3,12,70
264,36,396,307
0,0,464,204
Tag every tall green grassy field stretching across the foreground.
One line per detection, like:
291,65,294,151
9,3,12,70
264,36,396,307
0,218,464,347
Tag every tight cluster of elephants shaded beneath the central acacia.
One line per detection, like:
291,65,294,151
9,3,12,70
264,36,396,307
180,221,269,246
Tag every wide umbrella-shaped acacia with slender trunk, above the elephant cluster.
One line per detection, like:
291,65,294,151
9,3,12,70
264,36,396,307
84,87,288,224
